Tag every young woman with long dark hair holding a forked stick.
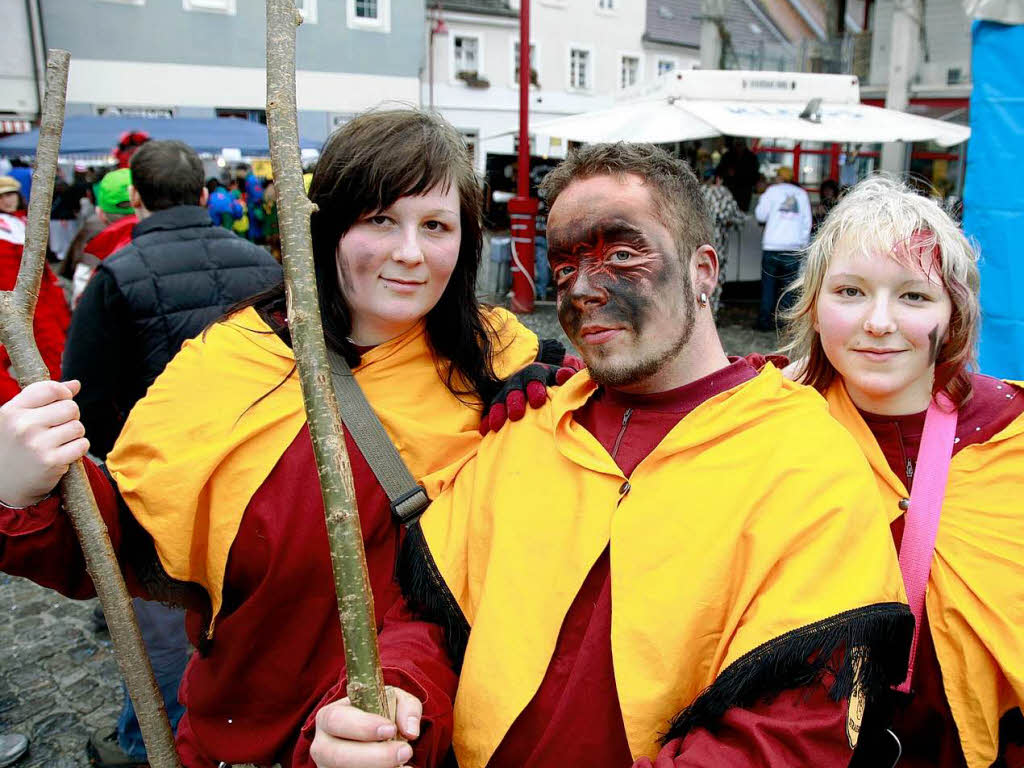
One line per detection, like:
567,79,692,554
0,111,560,766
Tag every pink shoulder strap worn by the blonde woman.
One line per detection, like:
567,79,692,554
897,392,957,693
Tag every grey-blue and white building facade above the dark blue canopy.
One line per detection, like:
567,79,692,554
0,0,424,140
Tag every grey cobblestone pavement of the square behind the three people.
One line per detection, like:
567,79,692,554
0,296,776,768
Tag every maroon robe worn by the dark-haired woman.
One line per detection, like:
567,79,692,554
0,427,457,768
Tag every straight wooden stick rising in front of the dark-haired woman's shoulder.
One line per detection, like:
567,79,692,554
266,0,389,717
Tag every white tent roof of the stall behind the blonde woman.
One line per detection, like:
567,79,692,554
516,70,971,146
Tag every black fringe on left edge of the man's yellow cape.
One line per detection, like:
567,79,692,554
397,520,469,672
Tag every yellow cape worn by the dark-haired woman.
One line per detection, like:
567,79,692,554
106,308,538,633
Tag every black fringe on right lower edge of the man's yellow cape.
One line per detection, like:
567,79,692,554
662,603,913,743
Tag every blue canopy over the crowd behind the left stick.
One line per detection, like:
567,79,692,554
0,115,321,156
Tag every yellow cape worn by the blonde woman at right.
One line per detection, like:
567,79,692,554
825,382,1024,768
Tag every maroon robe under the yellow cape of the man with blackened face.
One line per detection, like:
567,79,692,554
488,355,851,768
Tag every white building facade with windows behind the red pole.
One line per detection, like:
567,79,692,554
421,0,656,170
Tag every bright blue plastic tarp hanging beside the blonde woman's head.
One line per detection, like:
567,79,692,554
964,22,1024,380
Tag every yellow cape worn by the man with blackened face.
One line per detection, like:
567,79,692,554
421,365,910,768
